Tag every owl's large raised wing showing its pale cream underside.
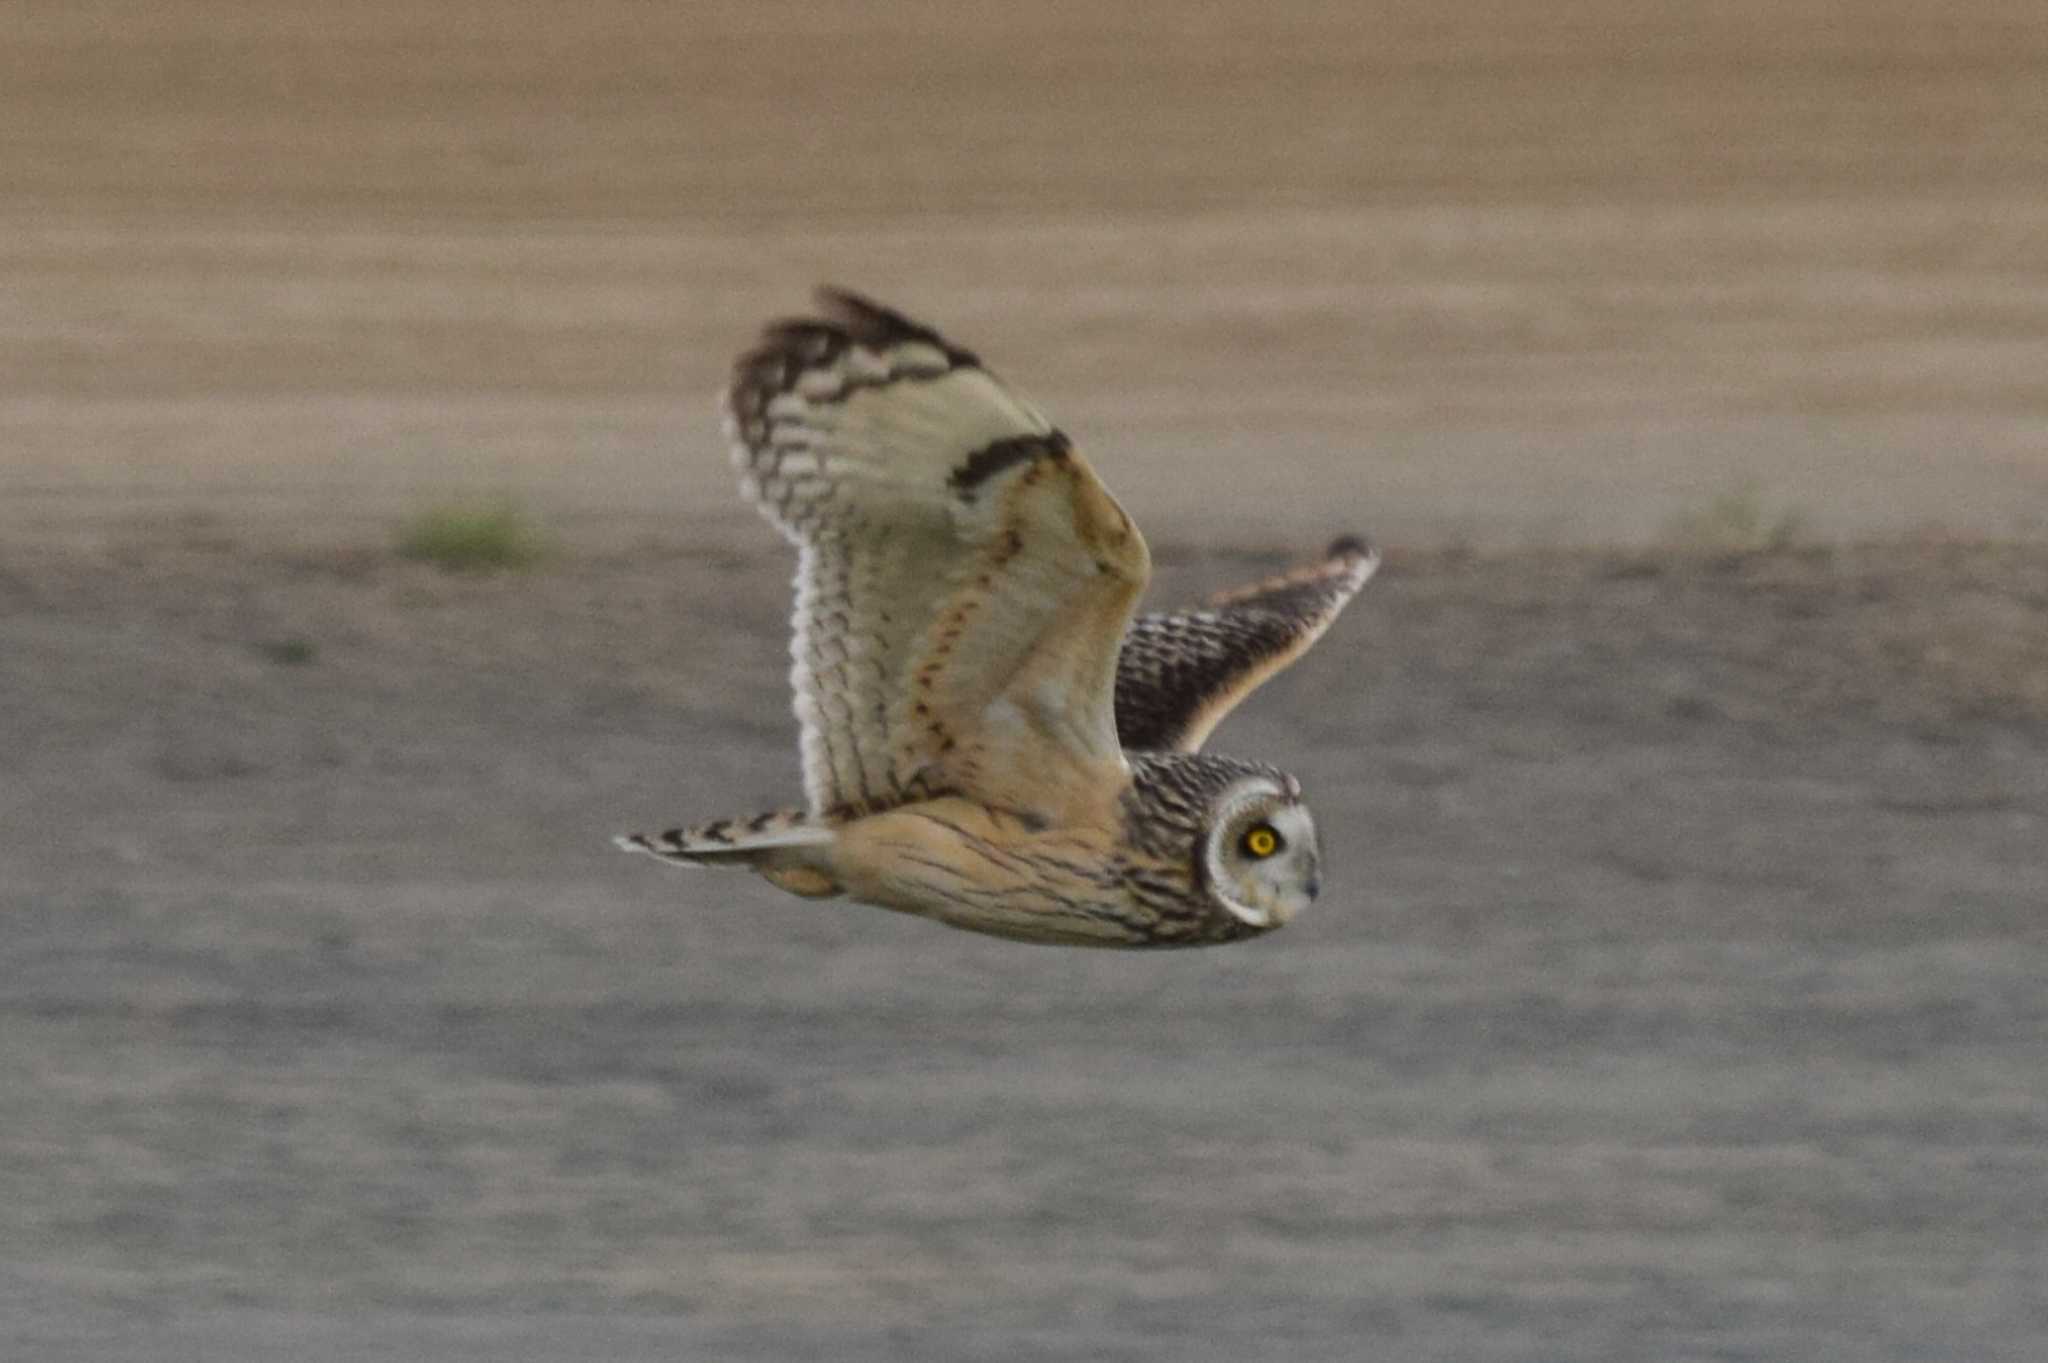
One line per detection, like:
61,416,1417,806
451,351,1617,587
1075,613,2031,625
727,289,1149,819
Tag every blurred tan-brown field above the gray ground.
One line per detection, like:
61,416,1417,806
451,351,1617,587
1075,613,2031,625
12,0,2048,544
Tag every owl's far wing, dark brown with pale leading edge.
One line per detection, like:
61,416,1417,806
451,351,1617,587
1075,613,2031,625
1116,536,1380,753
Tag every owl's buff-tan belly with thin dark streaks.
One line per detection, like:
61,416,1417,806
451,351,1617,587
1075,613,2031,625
831,798,1149,946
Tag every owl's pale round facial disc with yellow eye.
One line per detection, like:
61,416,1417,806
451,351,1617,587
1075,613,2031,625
1196,772,1323,929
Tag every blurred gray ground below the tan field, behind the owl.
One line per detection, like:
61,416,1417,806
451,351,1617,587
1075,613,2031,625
0,534,2048,1361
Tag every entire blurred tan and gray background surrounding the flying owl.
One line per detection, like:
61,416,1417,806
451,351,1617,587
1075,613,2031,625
0,0,2048,1363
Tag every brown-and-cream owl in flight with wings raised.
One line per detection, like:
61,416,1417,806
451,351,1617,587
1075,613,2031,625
616,291,1378,948
